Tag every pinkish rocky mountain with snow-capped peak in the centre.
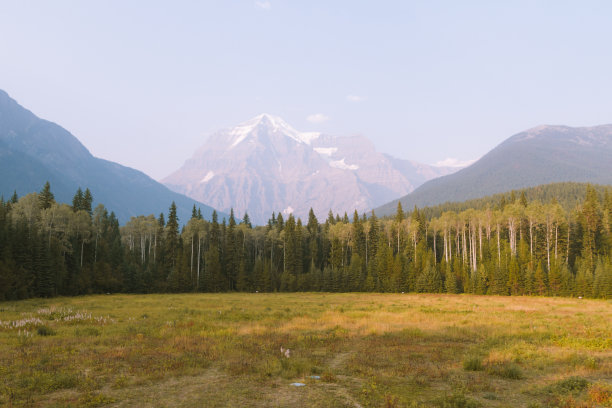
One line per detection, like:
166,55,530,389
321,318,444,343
162,114,457,224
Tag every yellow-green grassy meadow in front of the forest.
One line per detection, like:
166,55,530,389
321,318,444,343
0,293,612,408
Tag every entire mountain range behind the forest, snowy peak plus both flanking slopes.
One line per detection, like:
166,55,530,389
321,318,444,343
5,90,612,224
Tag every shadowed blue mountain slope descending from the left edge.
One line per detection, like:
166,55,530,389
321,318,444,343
0,90,223,223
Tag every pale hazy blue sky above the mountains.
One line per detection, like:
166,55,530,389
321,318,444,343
0,0,612,179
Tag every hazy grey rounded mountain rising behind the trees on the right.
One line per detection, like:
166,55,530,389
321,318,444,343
375,125,612,215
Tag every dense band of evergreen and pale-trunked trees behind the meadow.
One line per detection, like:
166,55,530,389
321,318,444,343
0,183,612,300
